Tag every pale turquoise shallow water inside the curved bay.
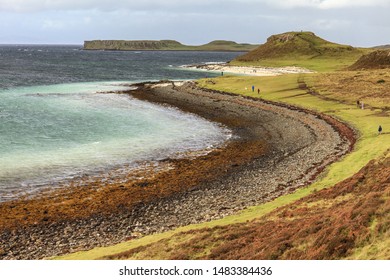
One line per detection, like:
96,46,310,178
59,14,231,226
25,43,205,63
0,82,229,200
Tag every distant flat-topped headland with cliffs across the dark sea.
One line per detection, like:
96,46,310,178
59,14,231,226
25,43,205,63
84,40,259,52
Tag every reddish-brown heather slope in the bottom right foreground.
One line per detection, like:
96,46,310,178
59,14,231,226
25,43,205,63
108,153,390,259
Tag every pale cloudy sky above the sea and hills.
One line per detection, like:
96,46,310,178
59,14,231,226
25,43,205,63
0,0,390,47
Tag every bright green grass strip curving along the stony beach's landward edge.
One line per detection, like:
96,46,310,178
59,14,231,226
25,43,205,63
56,75,390,259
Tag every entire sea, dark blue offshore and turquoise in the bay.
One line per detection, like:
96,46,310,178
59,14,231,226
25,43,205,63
0,45,240,202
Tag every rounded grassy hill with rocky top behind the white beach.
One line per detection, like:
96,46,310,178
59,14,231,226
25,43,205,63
231,32,369,71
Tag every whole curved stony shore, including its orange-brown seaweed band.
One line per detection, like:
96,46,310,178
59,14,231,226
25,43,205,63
0,82,355,259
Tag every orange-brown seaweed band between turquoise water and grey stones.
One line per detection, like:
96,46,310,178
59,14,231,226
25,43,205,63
0,138,264,230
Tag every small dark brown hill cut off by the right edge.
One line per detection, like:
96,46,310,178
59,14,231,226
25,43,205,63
348,50,390,70
